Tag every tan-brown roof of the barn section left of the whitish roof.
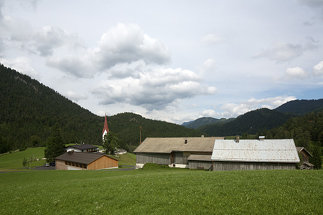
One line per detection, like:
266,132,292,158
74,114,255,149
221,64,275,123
134,137,223,153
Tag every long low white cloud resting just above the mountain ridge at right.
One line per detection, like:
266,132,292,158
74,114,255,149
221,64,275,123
221,96,296,117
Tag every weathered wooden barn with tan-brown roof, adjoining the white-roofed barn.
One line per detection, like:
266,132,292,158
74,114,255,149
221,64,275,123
134,137,223,168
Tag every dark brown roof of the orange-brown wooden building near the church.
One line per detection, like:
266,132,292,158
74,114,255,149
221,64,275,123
56,152,117,164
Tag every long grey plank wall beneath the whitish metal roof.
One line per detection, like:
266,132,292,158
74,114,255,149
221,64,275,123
213,161,296,171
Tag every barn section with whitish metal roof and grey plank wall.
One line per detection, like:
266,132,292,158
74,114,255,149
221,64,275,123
211,139,300,170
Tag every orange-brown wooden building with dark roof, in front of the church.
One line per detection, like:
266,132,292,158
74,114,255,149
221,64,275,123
55,151,118,170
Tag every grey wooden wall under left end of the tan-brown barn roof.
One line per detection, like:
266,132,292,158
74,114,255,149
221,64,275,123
136,153,170,165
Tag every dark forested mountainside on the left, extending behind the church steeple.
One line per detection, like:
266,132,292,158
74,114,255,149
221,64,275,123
0,64,201,153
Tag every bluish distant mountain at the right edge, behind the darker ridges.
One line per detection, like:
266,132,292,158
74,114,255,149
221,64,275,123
275,99,323,115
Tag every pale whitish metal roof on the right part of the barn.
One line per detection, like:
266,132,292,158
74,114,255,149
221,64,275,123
211,139,300,163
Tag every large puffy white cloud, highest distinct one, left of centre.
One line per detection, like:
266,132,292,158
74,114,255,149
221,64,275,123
94,23,169,69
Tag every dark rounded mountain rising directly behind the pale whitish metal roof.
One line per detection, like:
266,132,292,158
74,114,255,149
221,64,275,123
199,108,292,136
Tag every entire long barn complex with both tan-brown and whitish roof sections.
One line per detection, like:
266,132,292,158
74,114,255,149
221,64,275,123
134,137,300,170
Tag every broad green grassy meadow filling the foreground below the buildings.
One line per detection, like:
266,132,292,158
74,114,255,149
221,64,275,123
0,169,323,215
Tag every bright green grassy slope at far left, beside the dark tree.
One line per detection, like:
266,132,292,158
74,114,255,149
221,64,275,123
0,147,46,170
